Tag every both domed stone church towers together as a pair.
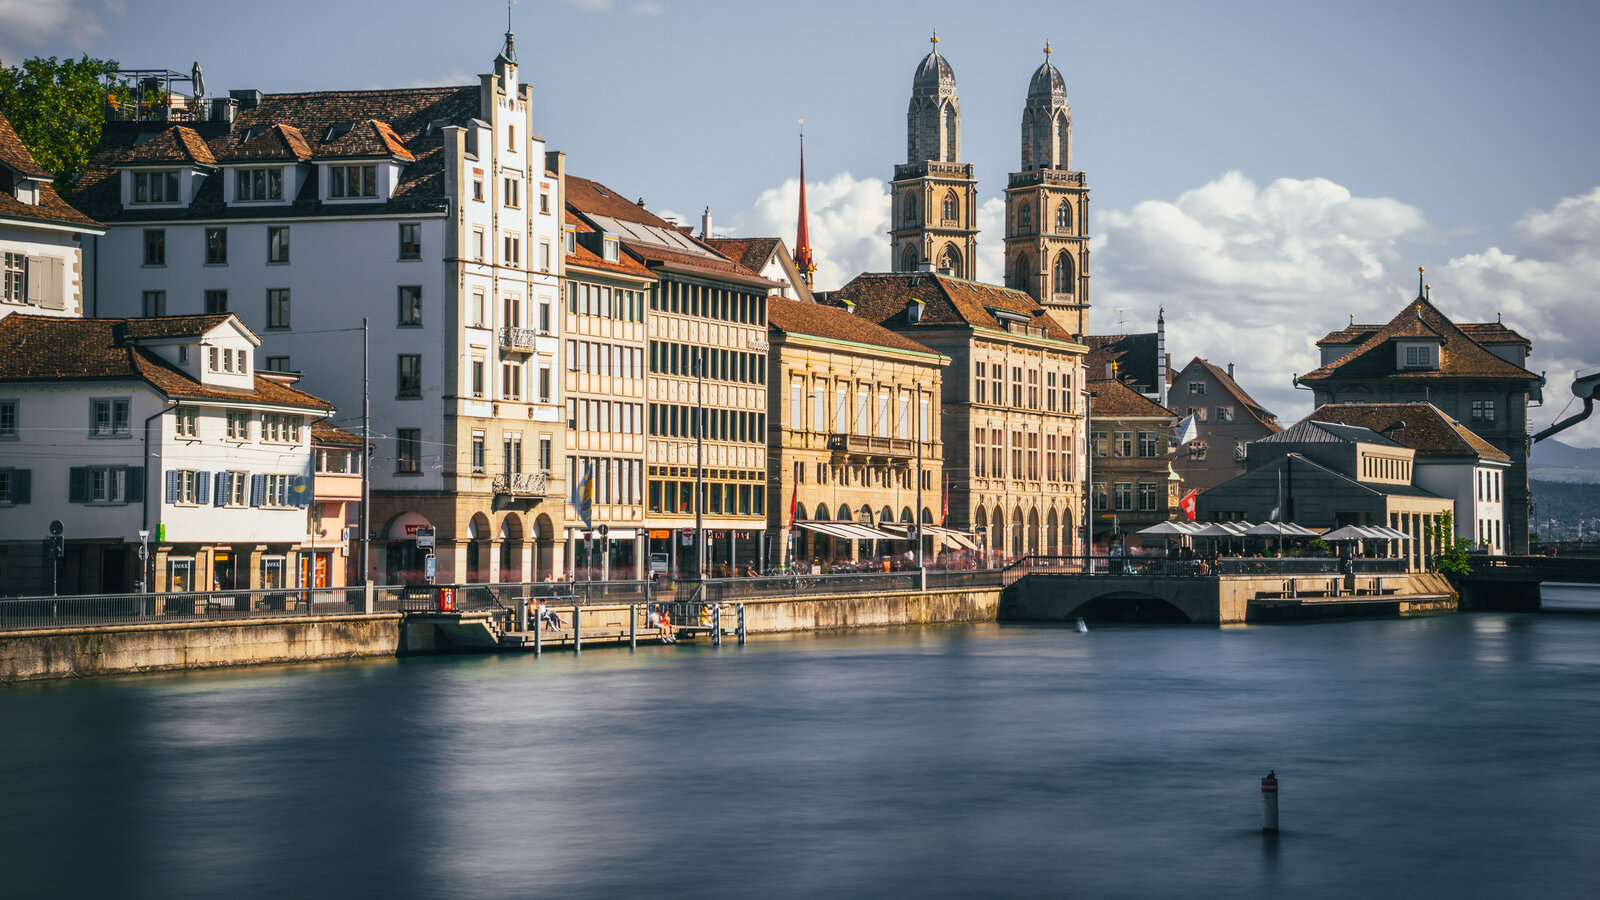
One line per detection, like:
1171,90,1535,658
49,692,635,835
890,34,1090,335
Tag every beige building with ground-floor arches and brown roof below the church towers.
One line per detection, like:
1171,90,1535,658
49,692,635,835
826,272,1088,557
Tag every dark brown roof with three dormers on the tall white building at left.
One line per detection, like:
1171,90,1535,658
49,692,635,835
72,85,480,223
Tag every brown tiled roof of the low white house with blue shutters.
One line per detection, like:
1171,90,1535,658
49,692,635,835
0,314,333,412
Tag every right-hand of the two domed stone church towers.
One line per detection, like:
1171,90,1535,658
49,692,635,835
1005,43,1090,335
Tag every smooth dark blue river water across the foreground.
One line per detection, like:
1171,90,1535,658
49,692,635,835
0,589,1600,898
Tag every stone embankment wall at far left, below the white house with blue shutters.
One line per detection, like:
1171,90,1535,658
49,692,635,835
0,613,400,682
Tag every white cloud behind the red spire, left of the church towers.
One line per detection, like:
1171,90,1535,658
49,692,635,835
717,171,890,290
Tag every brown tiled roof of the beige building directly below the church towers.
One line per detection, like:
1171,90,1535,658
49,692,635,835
818,272,1072,341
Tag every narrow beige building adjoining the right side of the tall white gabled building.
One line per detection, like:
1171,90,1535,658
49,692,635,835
562,211,656,578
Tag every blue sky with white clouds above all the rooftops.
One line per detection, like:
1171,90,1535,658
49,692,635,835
0,0,1600,445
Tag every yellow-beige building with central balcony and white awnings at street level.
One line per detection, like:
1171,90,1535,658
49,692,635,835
766,298,962,564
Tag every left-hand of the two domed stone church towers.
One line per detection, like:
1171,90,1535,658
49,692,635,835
890,32,978,279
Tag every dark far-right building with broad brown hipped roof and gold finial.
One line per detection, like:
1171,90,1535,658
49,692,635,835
1296,277,1544,554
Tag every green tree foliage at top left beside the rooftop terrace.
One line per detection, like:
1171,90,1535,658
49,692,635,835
0,54,126,194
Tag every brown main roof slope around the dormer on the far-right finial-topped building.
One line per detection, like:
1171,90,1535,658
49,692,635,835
1299,296,1538,384
